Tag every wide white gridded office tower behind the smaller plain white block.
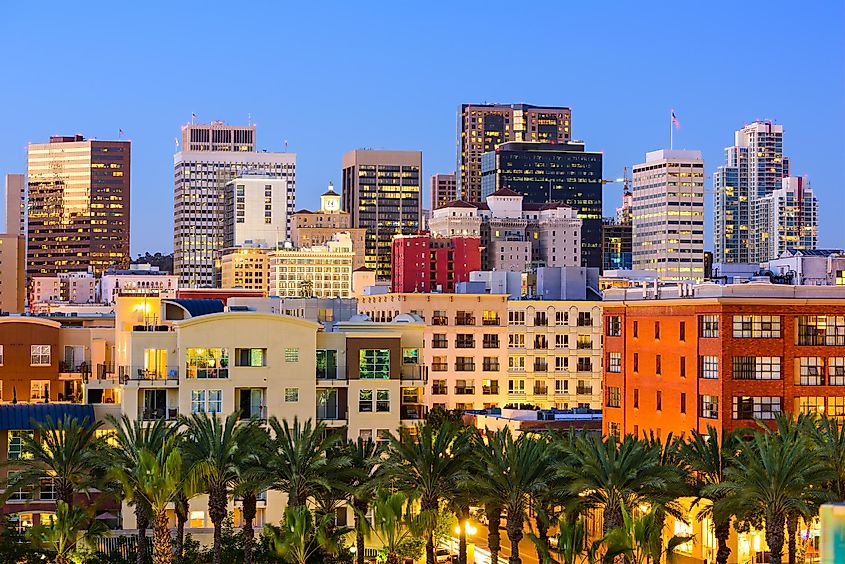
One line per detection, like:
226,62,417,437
173,121,296,288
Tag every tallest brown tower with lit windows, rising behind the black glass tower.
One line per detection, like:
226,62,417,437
457,104,572,202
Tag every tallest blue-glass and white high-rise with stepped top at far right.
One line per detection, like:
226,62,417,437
713,121,789,263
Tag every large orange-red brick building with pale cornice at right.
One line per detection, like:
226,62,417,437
603,283,845,437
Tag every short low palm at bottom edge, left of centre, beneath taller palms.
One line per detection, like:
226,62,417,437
265,505,348,564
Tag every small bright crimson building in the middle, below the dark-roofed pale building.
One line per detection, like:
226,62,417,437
390,233,481,293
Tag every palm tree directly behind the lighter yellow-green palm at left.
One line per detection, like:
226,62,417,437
106,414,174,564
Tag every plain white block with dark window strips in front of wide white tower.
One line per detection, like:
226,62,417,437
223,173,295,249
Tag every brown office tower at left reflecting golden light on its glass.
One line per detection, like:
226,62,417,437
27,135,131,276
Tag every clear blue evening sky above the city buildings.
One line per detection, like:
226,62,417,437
0,0,845,256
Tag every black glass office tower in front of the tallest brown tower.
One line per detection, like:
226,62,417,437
481,142,602,268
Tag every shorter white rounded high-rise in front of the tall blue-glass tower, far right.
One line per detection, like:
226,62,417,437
754,176,818,262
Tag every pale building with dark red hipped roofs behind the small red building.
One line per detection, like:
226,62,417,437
431,188,584,272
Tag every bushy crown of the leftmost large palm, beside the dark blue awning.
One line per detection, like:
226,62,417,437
4,415,106,506
